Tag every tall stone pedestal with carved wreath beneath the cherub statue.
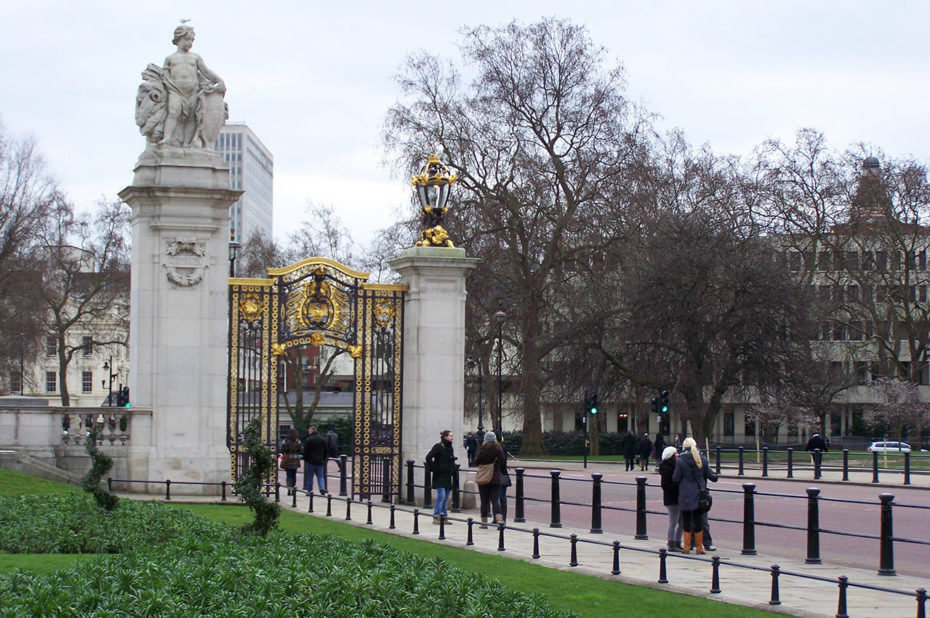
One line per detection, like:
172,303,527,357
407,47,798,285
119,149,242,493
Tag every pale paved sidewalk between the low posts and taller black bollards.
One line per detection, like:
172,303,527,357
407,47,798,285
216,482,928,617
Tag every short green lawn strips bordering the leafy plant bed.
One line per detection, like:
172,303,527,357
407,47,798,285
0,470,773,617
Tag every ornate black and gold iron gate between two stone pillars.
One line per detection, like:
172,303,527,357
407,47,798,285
226,258,406,498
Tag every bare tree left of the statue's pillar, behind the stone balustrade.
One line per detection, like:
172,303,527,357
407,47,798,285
38,200,129,406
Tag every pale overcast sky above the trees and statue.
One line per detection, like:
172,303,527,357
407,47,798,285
0,0,930,244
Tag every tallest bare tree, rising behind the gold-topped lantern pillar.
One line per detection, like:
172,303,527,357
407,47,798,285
385,19,643,454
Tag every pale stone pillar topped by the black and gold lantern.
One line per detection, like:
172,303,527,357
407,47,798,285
389,247,478,486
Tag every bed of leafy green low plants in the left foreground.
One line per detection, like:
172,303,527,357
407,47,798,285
0,498,566,617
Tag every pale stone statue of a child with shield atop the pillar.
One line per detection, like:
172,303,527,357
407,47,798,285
136,24,228,148
